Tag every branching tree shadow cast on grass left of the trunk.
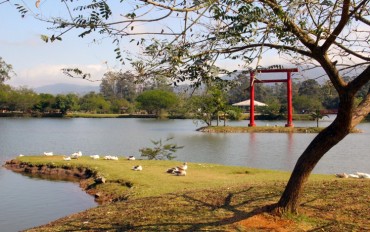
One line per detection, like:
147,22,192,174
127,187,279,232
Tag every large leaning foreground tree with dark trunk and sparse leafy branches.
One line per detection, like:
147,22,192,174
13,0,370,212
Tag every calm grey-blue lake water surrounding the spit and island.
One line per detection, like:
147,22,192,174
0,116,370,231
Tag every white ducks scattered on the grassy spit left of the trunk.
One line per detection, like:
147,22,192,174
39,151,188,176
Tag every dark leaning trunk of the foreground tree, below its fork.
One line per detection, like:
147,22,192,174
274,95,354,213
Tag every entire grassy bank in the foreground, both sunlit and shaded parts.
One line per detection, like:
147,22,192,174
3,156,370,231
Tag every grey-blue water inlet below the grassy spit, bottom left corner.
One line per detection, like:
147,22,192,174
0,168,97,231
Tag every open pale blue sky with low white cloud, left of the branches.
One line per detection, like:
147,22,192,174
0,0,290,88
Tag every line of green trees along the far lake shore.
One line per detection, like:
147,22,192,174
0,67,367,121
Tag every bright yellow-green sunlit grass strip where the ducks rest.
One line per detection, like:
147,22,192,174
15,156,329,197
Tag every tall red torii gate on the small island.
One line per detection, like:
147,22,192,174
249,68,298,127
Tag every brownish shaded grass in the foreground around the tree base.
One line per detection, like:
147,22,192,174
26,181,370,231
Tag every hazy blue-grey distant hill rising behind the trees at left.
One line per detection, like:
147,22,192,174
34,84,99,95
